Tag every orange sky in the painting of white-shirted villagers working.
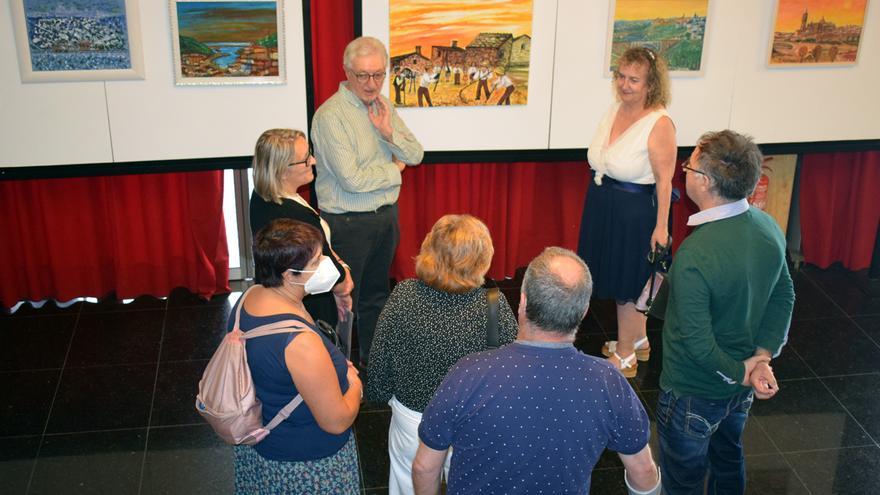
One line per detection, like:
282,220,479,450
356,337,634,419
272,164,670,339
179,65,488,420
389,0,532,57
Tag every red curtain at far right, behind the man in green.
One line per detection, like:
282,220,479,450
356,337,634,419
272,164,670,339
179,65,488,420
800,151,880,270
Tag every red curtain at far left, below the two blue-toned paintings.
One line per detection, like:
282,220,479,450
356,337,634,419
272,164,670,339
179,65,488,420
0,171,229,307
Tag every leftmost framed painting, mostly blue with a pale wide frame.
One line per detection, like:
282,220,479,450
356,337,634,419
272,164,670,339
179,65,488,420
10,0,144,82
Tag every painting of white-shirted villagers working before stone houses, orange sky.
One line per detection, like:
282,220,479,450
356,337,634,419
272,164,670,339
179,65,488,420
388,0,532,107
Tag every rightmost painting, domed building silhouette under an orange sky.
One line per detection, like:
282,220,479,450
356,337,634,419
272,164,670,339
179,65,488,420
769,0,868,66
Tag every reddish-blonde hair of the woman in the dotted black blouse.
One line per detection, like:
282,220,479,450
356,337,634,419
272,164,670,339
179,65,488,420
416,215,495,293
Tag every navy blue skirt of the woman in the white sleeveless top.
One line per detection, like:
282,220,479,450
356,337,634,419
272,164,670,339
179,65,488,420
578,176,657,302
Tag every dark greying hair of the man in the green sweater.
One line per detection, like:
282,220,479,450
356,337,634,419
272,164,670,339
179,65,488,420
697,129,764,201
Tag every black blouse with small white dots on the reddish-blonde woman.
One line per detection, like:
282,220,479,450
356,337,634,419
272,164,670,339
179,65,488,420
367,279,517,412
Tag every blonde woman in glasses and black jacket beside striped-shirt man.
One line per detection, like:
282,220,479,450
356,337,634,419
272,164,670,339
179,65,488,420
250,129,354,326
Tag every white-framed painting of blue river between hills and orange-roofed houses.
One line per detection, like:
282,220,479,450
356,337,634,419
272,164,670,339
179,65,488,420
171,0,285,85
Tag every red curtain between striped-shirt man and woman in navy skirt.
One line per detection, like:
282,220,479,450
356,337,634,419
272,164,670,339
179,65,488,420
392,162,588,279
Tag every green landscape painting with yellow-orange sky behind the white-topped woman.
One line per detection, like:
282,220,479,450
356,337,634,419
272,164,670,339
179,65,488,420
605,0,709,75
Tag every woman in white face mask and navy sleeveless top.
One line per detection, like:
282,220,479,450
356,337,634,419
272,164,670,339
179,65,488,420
229,219,363,494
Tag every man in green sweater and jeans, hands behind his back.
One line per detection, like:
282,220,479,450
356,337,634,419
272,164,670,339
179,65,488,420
657,130,794,495
